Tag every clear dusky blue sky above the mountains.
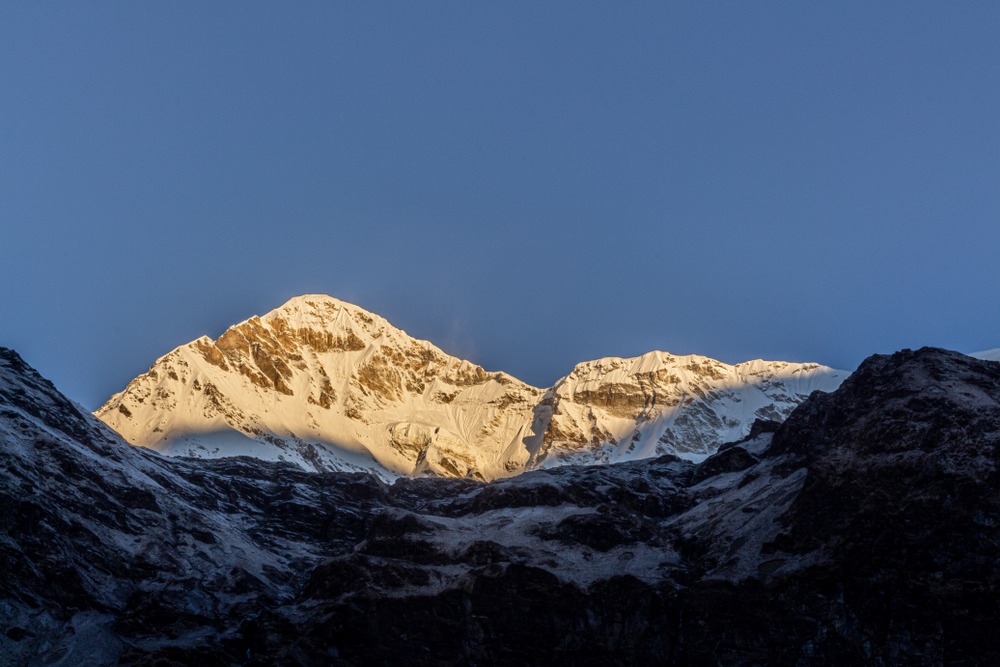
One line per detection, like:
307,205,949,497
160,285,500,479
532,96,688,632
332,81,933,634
0,1,1000,408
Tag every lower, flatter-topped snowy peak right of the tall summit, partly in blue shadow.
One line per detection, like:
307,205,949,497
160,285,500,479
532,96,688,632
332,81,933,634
529,352,848,467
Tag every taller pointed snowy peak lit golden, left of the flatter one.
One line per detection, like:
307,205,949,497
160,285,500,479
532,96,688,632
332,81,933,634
96,295,542,479
